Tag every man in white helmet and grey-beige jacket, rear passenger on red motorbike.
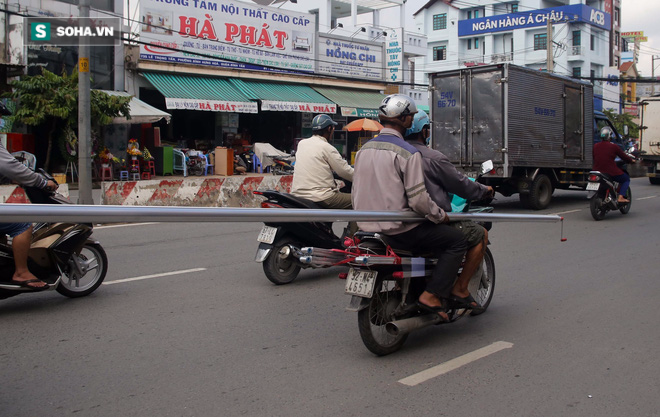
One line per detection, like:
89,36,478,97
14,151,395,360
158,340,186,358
353,94,467,321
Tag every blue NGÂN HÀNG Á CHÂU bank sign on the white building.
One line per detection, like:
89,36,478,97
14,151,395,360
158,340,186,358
458,4,612,36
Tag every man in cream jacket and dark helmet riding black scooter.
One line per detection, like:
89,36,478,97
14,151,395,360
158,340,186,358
291,114,353,209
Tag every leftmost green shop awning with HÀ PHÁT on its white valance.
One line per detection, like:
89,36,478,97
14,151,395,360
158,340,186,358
142,72,258,113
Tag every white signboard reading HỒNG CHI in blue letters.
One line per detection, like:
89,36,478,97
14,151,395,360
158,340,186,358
316,34,384,81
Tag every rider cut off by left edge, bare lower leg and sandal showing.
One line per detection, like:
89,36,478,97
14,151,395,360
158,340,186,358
0,144,57,289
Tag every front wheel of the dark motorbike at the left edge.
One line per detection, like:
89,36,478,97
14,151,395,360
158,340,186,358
56,243,108,298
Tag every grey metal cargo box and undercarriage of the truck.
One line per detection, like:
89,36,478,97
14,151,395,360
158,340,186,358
429,64,595,209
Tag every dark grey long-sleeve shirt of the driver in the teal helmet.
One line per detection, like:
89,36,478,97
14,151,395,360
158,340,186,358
409,142,488,211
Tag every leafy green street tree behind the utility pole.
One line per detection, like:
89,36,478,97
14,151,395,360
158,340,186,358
5,68,131,171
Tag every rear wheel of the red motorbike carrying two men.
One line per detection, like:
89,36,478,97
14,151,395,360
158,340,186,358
358,278,408,356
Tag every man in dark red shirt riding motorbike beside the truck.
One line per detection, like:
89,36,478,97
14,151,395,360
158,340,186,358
593,126,635,203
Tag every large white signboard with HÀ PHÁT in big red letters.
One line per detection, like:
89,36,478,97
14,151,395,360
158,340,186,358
140,0,316,73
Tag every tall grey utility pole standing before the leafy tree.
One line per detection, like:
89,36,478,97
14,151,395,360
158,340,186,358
78,0,94,204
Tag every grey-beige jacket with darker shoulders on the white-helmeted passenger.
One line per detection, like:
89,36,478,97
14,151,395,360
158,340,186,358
351,128,445,235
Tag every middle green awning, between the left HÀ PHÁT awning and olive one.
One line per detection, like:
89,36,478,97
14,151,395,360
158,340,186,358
230,78,337,114
